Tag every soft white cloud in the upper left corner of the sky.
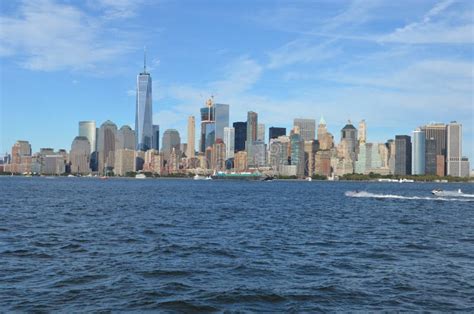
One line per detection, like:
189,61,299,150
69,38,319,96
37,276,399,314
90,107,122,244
0,0,134,71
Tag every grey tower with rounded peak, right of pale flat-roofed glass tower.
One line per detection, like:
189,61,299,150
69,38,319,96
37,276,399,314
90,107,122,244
97,120,117,174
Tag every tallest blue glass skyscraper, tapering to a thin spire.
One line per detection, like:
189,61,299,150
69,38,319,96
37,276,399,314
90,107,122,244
135,51,153,151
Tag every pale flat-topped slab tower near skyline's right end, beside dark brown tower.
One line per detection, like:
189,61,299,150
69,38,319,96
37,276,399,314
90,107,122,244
446,121,462,177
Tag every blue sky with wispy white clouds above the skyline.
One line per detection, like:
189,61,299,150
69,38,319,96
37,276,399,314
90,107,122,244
0,0,474,163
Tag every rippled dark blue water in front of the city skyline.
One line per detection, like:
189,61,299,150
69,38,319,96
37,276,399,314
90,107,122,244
0,178,474,312
